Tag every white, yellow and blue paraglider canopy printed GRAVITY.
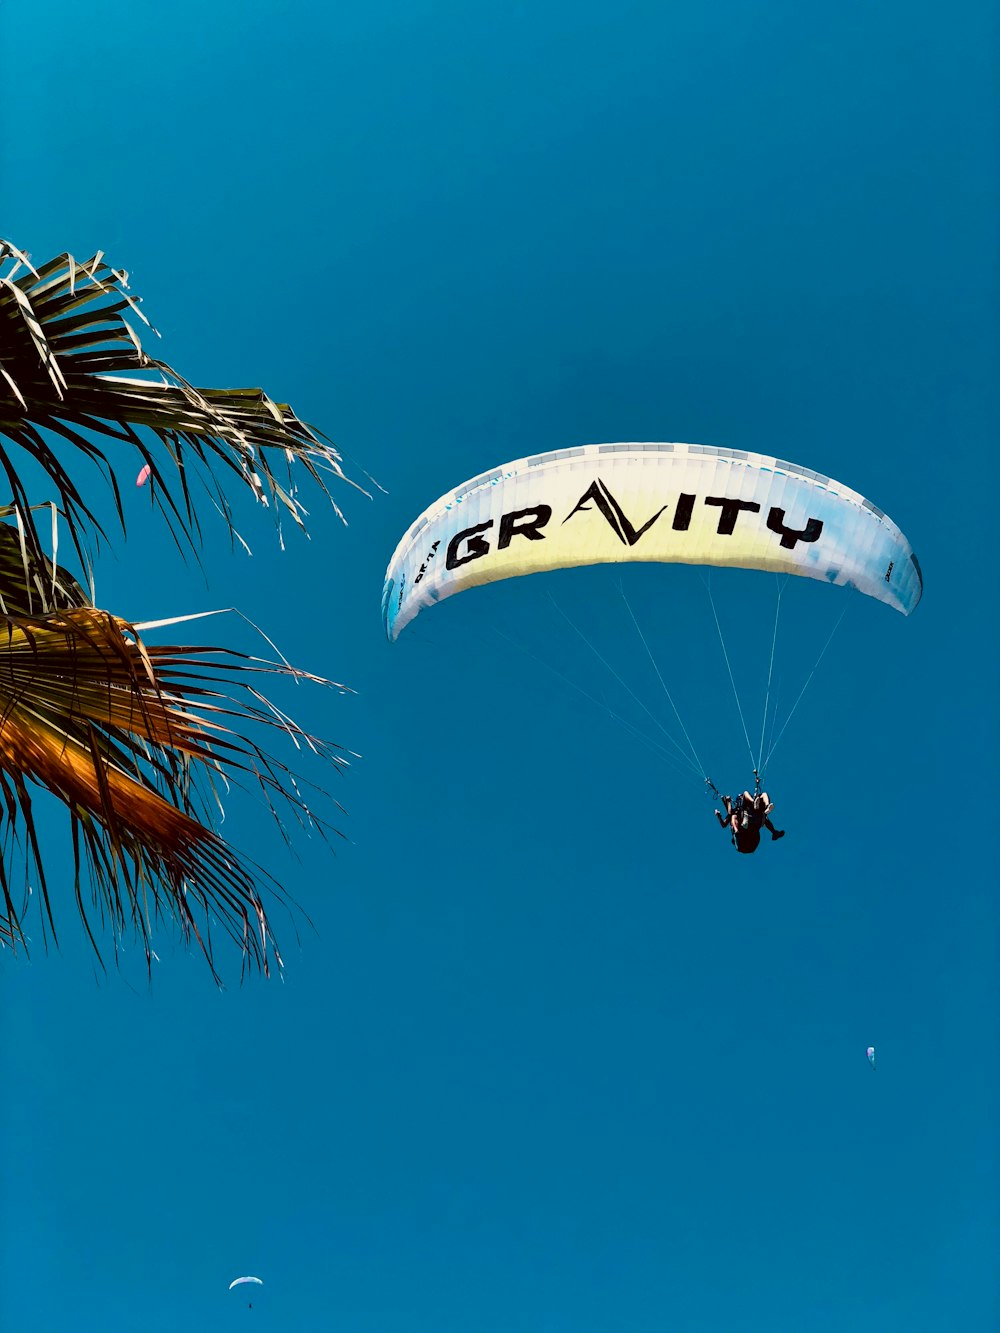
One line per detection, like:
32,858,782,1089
383,444,923,640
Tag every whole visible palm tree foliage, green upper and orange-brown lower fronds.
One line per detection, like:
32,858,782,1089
0,241,360,973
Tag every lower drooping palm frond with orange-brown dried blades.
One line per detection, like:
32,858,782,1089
0,607,345,973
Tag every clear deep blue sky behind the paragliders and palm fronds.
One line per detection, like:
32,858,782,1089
0,0,1000,1333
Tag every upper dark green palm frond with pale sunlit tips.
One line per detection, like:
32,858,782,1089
0,240,368,573
